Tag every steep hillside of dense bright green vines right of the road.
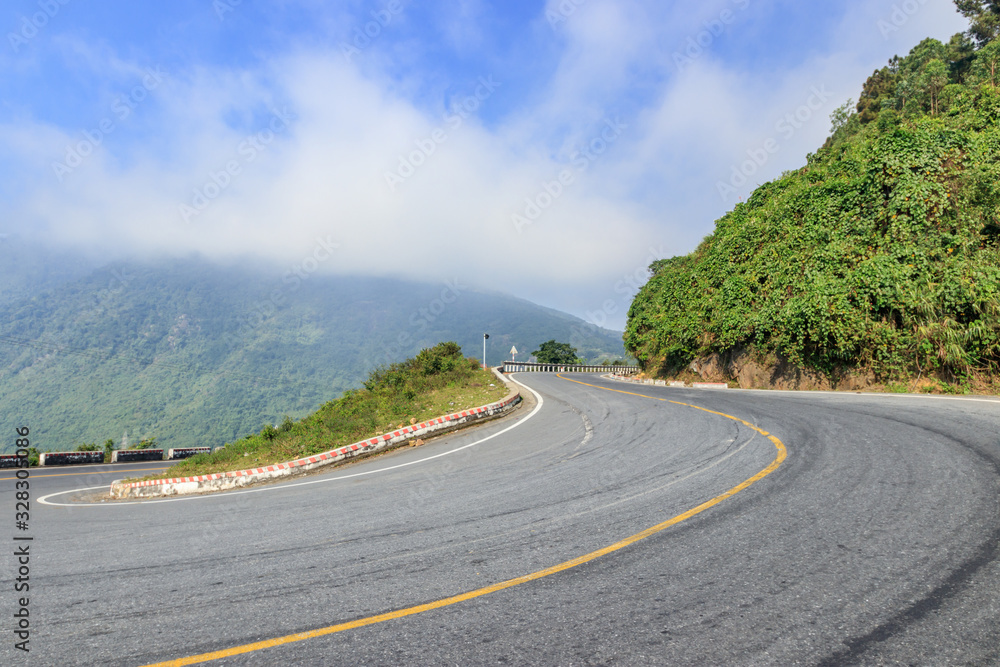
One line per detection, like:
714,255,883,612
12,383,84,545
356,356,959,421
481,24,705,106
625,30,1000,381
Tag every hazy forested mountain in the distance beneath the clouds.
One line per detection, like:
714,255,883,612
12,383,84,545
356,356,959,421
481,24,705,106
0,259,624,450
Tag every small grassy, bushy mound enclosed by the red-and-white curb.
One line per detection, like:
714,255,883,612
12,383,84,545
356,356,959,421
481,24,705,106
162,342,507,477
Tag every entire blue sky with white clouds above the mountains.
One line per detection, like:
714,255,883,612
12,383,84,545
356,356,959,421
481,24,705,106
0,0,966,328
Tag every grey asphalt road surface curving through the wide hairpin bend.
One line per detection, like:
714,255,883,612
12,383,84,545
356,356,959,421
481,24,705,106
0,375,1000,665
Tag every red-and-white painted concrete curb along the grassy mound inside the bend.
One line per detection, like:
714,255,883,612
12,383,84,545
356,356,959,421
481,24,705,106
111,370,521,499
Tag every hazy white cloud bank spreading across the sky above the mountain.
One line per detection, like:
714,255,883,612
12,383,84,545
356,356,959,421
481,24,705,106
0,0,976,327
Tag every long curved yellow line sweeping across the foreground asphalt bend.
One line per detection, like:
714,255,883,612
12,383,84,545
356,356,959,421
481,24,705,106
145,375,788,667
